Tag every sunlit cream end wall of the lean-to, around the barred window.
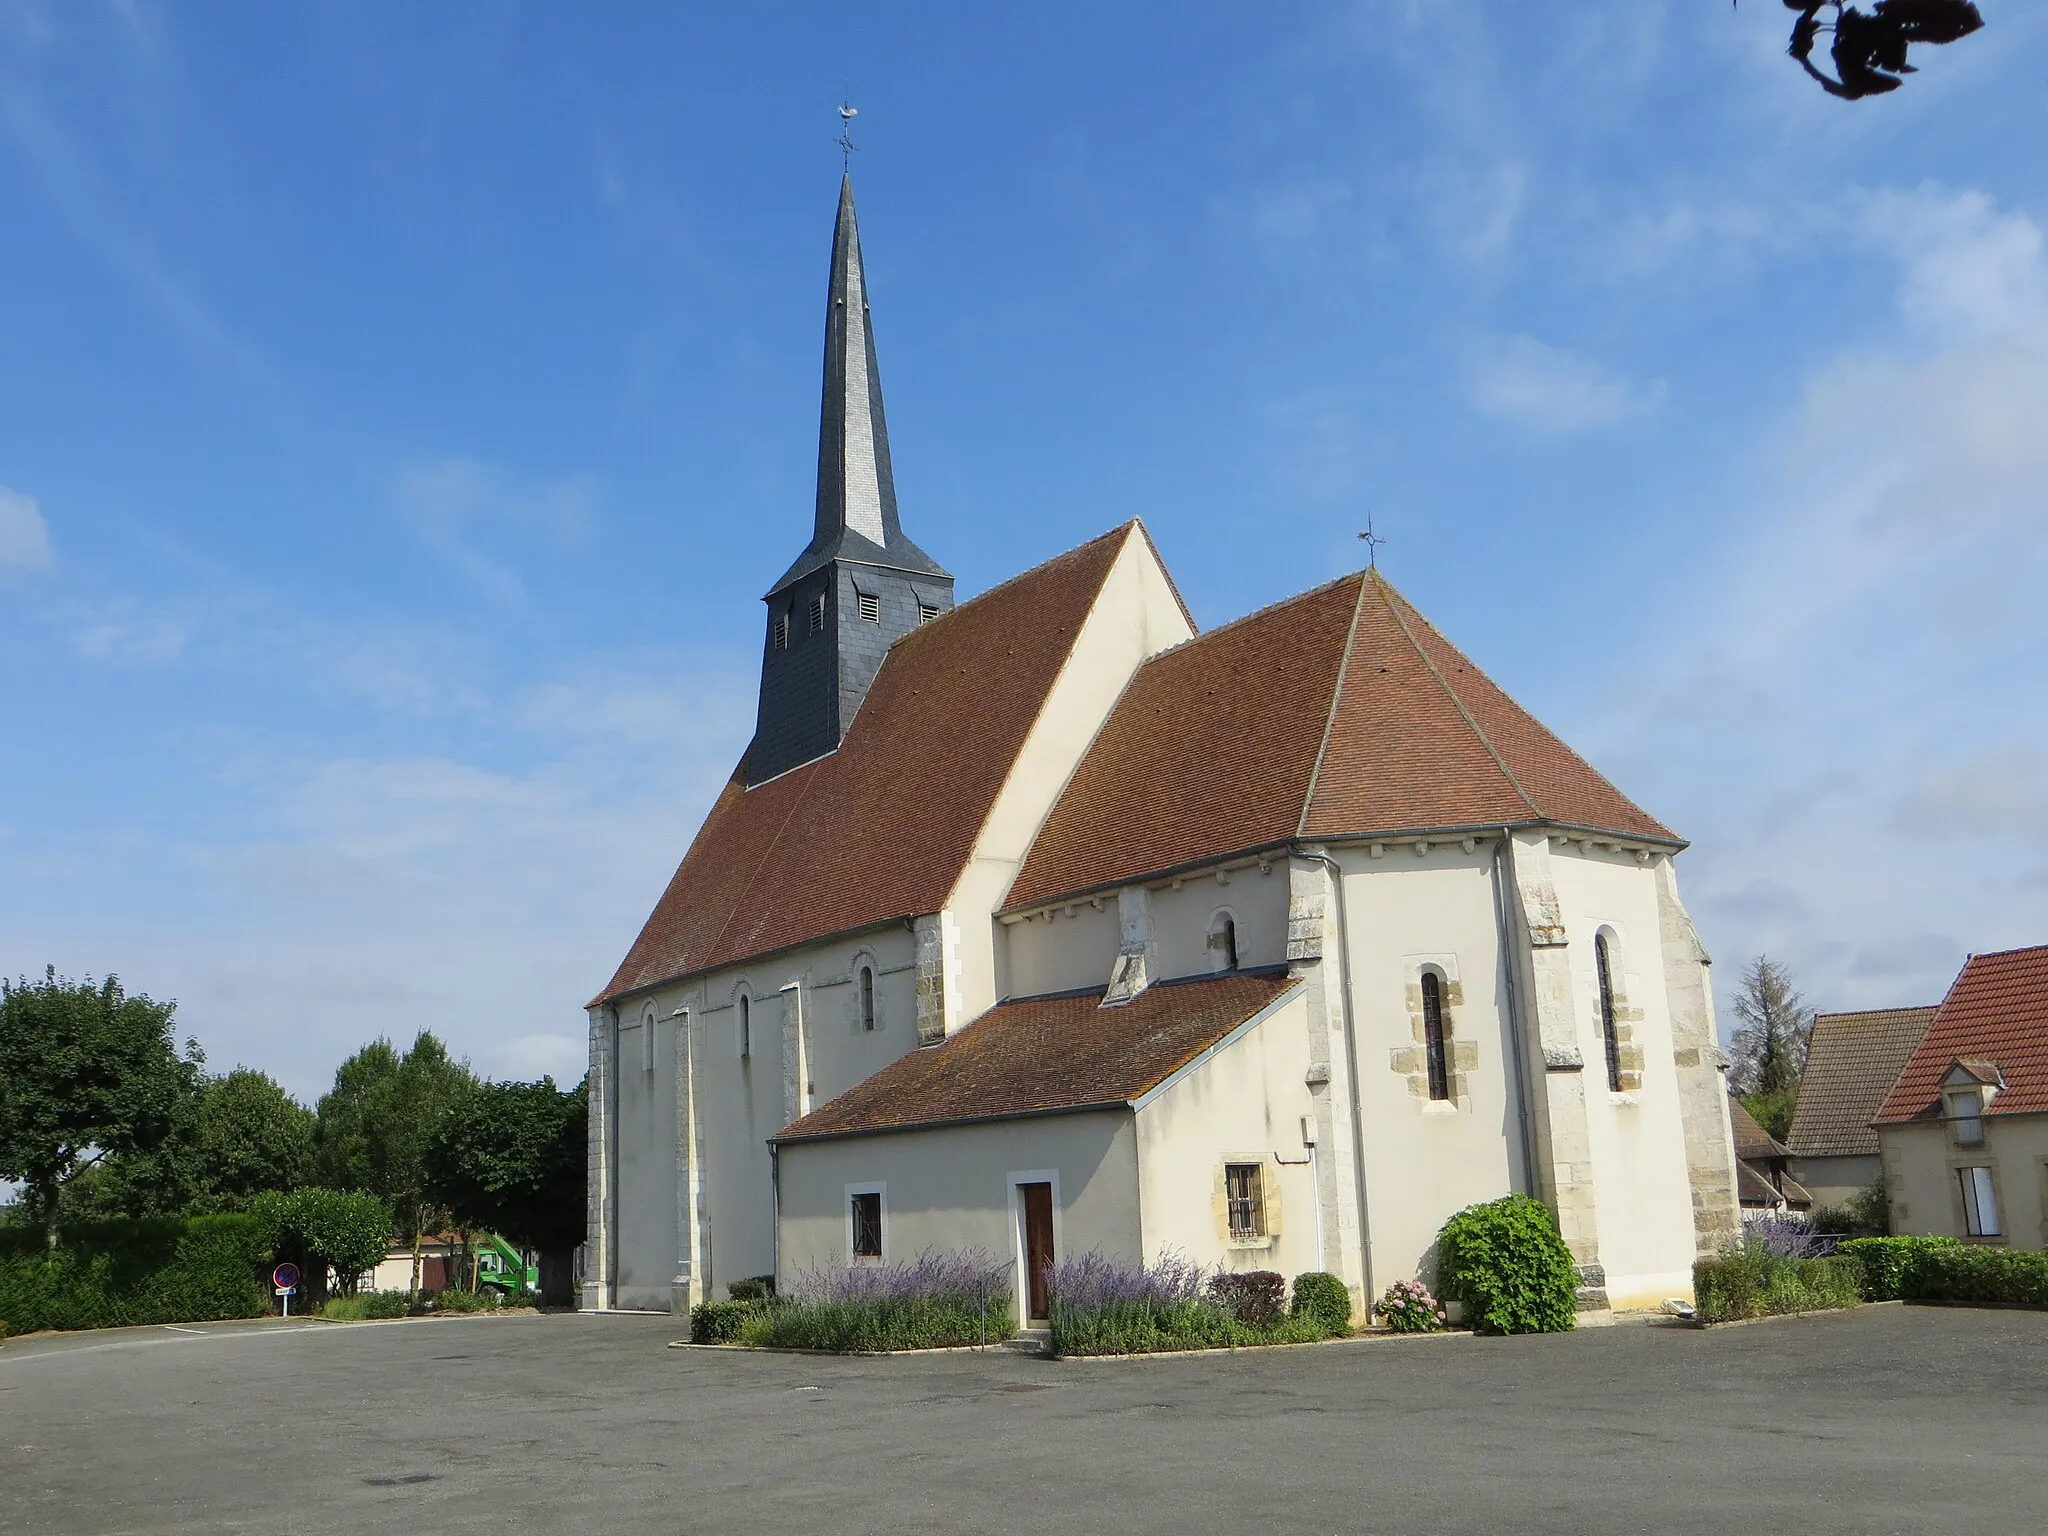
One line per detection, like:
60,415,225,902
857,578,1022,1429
1137,993,1341,1280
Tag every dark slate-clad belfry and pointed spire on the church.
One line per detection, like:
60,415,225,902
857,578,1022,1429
745,178,952,784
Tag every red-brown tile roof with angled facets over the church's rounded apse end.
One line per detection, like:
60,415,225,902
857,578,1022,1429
1006,571,1679,909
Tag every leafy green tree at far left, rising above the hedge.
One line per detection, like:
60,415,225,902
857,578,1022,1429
0,967,205,1247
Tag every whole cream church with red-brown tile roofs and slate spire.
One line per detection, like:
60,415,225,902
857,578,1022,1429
584,184,1739,1323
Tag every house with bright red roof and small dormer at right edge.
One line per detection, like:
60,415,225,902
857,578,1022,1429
1876,944,2048,1247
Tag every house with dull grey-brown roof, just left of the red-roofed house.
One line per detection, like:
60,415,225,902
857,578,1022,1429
1794,1008,1935,1206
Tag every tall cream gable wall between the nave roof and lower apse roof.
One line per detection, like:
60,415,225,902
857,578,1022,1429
946,528,1194,1030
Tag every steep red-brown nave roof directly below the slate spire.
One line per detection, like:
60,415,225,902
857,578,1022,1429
600,522,1145,1011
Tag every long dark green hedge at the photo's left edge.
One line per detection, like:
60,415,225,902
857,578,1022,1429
0,1214,270,1333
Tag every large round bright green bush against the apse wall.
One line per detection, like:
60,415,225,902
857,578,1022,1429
1436,1194,1579,1333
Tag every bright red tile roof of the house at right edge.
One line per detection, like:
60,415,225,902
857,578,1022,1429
1876,944,2048,1124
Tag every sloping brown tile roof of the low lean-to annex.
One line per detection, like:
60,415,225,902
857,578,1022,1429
776,971,1296,1141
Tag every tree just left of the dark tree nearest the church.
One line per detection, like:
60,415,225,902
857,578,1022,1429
315,1030,477,1300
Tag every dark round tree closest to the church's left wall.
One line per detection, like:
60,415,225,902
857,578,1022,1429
428,1077,590,1307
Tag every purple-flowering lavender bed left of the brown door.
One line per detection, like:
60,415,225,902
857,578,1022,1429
733,1247,1014,1354
